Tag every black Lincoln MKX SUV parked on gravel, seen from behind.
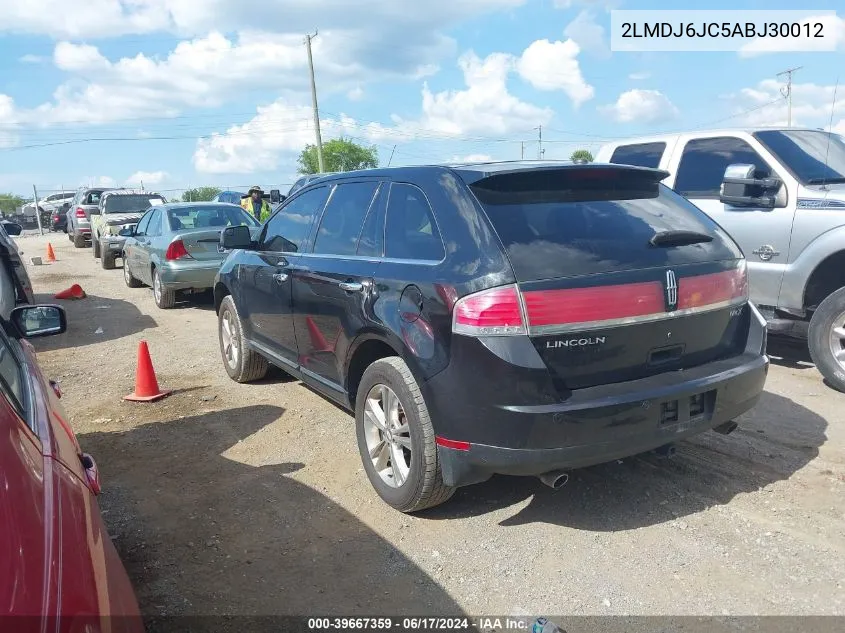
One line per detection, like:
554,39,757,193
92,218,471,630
209,163,768,512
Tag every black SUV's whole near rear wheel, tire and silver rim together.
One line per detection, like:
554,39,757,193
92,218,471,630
355,356,455,512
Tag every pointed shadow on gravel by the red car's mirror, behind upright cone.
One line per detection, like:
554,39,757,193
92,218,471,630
33,294,158,351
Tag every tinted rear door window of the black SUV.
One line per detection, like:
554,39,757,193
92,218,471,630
314,182,378,255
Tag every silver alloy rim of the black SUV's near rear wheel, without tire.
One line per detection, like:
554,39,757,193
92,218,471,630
364,385,412,488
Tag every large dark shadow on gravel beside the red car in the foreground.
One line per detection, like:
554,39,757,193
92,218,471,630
79,405,460,631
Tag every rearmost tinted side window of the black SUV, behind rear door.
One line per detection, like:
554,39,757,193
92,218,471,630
385,183,446,261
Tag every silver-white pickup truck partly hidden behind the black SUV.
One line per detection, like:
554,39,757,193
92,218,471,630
596,128,845,391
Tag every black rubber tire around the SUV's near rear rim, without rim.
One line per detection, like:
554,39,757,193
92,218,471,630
355,356,455,512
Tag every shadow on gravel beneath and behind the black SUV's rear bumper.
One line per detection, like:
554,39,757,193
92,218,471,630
418,392,827,532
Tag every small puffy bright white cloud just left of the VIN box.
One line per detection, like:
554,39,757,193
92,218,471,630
516,39,594,108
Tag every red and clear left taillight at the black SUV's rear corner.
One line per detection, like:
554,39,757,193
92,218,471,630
452,286,526,336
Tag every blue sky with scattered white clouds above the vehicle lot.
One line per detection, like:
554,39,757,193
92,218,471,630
0,0,845,194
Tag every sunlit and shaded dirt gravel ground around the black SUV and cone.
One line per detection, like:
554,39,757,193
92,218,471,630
18,233,845,616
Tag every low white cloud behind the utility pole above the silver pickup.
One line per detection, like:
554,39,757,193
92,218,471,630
729,79,845,128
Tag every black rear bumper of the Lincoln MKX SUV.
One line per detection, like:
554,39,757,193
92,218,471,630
421,310,769,486
